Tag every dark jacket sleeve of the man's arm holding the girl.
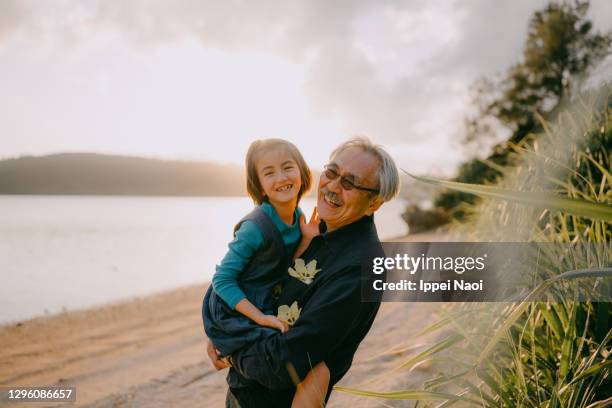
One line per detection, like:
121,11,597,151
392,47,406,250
232,266,369,389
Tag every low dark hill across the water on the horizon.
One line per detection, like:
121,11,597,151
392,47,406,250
0,153,246,196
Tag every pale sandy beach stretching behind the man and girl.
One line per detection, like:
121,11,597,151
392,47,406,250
0,234,450,408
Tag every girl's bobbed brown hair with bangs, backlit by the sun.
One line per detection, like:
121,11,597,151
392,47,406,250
245,139,312,205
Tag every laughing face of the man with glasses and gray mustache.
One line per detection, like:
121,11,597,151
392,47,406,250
317,147,382,231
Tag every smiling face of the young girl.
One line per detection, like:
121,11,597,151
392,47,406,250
255,149,302,205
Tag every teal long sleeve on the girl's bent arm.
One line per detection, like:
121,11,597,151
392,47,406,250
212,221,263,309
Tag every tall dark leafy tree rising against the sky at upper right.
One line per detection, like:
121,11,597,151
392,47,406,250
435,0,612,218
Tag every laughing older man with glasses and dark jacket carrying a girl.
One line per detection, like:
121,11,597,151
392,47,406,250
208,138,399,408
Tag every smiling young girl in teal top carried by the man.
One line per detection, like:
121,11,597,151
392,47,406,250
202,139,329,407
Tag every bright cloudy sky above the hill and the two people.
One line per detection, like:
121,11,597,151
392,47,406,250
0,0,612,174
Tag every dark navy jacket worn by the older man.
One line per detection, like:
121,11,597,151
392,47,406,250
228,216,384,407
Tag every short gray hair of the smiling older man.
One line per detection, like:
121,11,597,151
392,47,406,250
329,136,400,202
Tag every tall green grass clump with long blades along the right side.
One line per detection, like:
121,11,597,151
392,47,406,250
339,86,612,408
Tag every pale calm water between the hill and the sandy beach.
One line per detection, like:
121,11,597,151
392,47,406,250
0,196,406,323
